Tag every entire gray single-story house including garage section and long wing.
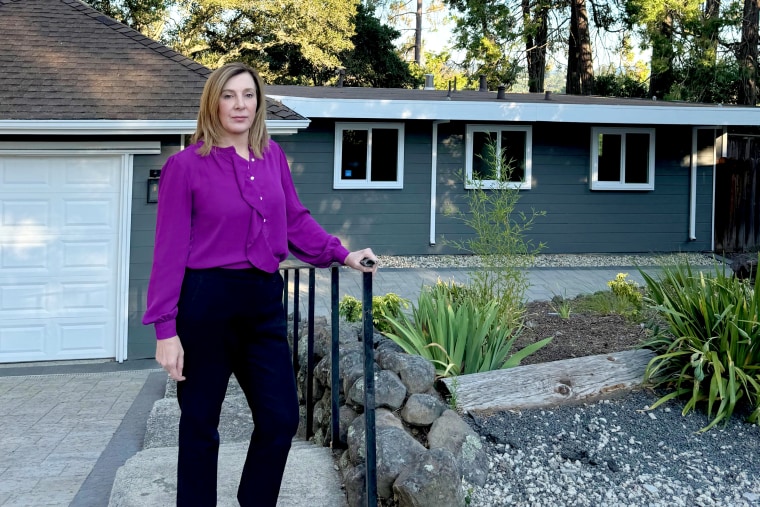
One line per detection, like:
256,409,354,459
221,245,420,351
0,0,760,363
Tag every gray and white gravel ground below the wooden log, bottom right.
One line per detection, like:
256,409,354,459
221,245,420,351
470,391,760,507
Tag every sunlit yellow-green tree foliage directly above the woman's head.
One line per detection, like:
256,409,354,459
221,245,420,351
170,0,356,85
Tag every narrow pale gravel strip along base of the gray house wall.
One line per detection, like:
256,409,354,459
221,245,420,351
378,253,719,268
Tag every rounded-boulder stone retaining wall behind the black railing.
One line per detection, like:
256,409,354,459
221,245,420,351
291,317,488,507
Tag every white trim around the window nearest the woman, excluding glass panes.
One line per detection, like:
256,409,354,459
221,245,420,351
333,122,404,190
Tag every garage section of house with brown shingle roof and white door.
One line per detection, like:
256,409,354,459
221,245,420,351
0,0,308,363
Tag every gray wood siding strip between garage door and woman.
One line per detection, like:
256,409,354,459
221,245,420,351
127,136,180,360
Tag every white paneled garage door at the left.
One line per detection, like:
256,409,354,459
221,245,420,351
0,154,122,363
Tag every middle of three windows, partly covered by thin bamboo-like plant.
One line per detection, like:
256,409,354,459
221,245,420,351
465,125,533,189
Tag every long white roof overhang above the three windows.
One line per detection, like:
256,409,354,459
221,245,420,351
269,95,760,126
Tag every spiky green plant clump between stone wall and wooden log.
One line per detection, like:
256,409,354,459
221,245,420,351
387,282,551,377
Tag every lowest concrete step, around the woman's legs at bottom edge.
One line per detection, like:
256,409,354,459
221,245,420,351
108,440,347,507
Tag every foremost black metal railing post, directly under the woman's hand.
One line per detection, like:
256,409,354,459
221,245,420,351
362,273,377,507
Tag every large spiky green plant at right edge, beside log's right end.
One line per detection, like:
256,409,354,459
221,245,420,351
642,263,760,431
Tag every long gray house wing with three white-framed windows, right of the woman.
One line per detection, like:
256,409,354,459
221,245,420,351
267,86,760,255
